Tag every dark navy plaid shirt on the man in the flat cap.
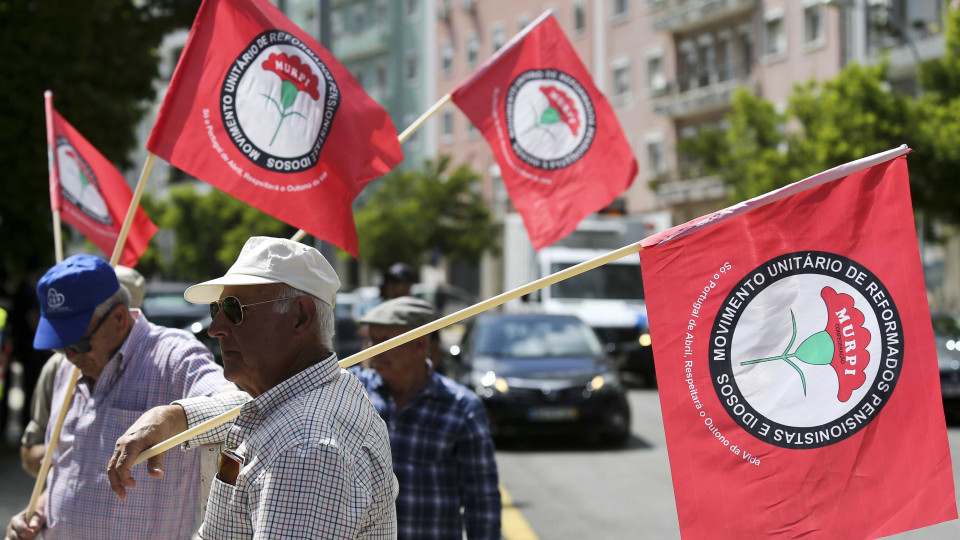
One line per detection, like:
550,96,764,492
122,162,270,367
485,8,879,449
351,363,501,540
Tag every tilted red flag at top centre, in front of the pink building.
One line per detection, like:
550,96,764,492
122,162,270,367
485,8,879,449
451,13,637,249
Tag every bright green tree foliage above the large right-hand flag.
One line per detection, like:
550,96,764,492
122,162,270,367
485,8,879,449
678,9,960,230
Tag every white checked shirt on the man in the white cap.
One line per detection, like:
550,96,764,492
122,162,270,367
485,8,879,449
177,355,397,539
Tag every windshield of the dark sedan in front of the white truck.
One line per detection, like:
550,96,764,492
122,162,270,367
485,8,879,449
476,318,603,358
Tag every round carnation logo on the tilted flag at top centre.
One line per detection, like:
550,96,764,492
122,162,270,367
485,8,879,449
506,69,597,171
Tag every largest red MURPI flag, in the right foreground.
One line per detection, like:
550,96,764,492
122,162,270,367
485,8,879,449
641,147,957,539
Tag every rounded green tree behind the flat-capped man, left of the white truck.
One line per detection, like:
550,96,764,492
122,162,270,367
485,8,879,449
355,157,497,270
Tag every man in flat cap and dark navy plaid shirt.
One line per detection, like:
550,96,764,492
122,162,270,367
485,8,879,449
354,296,501,540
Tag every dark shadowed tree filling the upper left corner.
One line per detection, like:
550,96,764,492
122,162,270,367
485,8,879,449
0,0,200,272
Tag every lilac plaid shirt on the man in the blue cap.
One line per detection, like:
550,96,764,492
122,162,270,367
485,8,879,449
44,310,236,540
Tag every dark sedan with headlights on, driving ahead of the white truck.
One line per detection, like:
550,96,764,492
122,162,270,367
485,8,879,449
449,314,630,445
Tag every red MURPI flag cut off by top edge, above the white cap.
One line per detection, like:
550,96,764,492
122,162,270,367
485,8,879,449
147,0,403,256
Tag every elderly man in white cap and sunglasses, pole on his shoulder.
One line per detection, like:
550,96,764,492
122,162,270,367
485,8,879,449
108,237,398,538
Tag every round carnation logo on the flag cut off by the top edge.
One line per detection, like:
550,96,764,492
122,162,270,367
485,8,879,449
220,30,340,173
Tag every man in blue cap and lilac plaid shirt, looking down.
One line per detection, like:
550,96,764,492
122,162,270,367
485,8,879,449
7,255,235,540
